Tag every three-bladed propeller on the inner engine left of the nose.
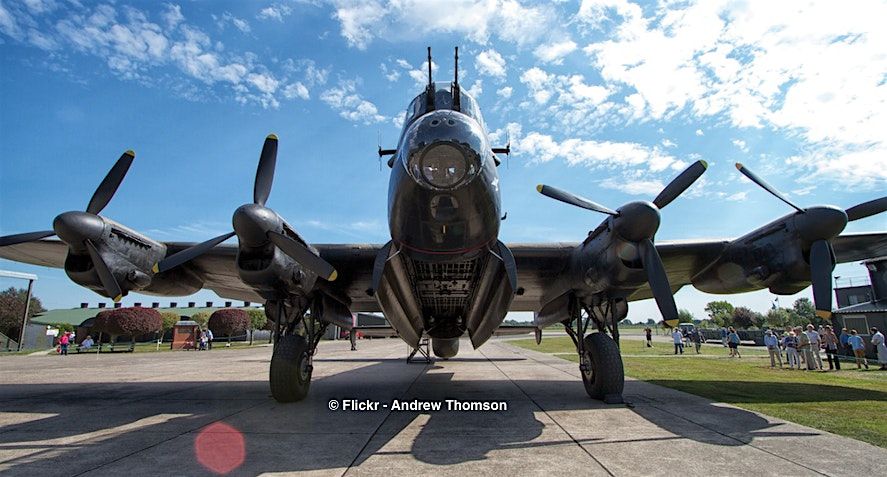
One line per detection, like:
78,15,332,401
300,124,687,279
154,134,337,281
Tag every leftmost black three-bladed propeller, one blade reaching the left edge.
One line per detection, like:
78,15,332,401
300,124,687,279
0,151,135,302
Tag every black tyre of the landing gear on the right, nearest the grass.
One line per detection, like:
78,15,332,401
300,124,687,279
579,333,625,404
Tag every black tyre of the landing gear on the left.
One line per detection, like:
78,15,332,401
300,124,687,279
269,335,312,402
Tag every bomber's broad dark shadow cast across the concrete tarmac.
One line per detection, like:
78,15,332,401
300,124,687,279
0,360,887,475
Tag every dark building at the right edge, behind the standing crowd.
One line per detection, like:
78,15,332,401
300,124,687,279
833,257,887,357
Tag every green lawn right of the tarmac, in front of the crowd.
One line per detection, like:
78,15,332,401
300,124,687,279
510,337,887,448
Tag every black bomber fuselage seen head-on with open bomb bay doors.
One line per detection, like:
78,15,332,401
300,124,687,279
379,83,510,352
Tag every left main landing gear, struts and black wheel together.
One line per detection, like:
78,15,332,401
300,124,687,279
265,298,328,402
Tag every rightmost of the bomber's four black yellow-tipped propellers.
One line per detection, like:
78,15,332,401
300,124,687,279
736,163,887,318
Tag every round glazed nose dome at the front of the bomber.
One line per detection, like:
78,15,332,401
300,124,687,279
405,111,485,189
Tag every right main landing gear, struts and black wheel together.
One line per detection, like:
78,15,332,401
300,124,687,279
563,299,628,404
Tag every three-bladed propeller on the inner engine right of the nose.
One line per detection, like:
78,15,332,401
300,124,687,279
536,161,708,327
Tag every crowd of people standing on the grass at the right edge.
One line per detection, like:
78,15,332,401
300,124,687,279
764,324,887,371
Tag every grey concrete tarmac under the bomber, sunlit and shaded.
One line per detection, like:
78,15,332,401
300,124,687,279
0,339,887,476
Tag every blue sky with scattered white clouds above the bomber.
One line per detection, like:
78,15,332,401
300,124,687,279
0,0,887,321
